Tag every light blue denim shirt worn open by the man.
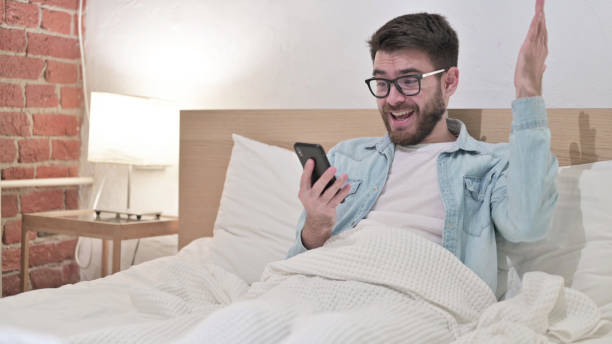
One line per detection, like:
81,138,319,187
288,97,558,292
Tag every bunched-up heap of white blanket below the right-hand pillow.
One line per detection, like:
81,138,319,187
457,272,610,344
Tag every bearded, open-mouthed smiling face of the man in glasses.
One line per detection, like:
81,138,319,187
374,49,446,145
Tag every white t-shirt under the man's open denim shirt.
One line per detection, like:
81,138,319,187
359,142,454,244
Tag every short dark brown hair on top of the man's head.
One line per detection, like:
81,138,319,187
368,13,459,69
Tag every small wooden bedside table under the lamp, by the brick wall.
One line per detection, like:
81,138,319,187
20,209,178,291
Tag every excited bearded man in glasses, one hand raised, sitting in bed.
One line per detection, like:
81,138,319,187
289,0,557,296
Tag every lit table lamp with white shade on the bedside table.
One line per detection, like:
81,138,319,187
87,92,178,220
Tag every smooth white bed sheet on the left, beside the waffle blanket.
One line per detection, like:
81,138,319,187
0,238,248,343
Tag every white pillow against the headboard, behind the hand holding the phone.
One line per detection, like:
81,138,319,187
211,134,302,284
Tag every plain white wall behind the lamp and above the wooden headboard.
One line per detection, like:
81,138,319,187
85,0,612,213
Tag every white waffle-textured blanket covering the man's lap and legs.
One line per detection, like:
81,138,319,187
183,227,600,343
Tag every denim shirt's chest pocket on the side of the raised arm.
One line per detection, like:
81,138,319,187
463,176,491,236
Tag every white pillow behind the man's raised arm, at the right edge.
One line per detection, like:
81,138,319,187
500,161,612,306
